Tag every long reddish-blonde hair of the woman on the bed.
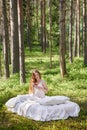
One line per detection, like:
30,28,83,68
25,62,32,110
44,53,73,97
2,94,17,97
29,70,41,93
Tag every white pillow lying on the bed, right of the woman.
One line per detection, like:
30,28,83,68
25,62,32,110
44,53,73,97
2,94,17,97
40,96,69,105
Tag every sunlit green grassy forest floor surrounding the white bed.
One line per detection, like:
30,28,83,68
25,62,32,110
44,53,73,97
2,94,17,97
0,48,87,130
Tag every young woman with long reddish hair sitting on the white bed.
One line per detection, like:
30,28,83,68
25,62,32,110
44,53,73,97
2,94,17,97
29,70,48,97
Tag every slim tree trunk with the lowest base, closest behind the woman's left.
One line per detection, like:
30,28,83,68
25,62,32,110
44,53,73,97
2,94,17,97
17,0,26,84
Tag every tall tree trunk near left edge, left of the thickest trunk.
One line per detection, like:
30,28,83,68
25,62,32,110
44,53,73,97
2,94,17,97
1,0,10,78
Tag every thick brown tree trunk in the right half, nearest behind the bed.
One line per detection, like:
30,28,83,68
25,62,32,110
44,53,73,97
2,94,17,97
60,0,66,77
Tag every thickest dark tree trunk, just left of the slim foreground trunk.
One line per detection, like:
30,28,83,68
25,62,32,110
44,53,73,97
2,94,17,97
10,0,19,73
